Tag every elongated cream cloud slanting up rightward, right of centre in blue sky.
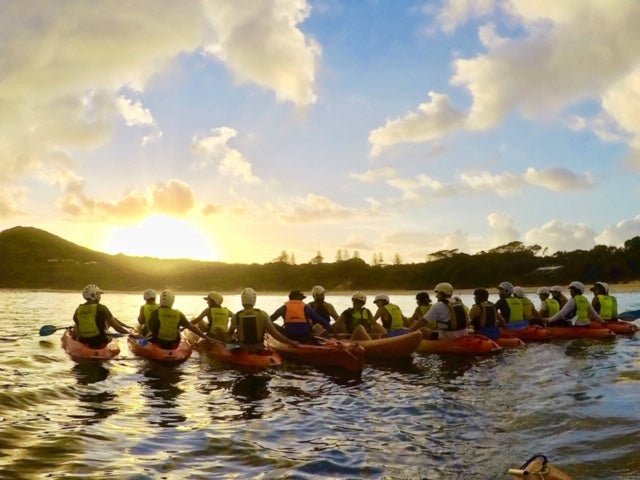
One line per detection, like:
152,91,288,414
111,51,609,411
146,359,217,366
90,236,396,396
369,92,464,157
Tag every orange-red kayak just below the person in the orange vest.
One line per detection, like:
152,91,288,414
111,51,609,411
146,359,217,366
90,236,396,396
265,335,364,372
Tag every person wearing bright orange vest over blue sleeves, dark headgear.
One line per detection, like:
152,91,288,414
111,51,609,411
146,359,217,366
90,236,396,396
271,290,331,342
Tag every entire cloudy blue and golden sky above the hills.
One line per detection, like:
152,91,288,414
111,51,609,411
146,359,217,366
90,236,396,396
0,0,640,263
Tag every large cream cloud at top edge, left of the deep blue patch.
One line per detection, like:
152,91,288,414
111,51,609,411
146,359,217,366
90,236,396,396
203,0,321,107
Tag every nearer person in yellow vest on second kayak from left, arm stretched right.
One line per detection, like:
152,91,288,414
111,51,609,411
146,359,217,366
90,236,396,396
148,290,211,350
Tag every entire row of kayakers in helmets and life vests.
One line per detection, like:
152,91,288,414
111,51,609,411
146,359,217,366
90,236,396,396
73,281,617,350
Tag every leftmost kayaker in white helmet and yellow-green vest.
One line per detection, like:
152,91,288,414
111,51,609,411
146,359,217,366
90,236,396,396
73,284,133,348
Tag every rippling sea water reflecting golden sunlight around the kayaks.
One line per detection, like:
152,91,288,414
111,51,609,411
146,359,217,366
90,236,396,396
0,291,640,480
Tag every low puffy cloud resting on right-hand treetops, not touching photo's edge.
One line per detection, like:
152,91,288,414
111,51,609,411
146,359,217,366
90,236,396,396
524,220,596,252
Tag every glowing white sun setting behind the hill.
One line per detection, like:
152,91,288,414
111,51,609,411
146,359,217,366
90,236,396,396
105,215,218,261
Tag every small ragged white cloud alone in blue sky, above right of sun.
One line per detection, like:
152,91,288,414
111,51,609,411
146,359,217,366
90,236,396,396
191,127,260,183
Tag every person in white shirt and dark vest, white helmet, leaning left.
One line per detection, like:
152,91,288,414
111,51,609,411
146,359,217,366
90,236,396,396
409,282,469,340
